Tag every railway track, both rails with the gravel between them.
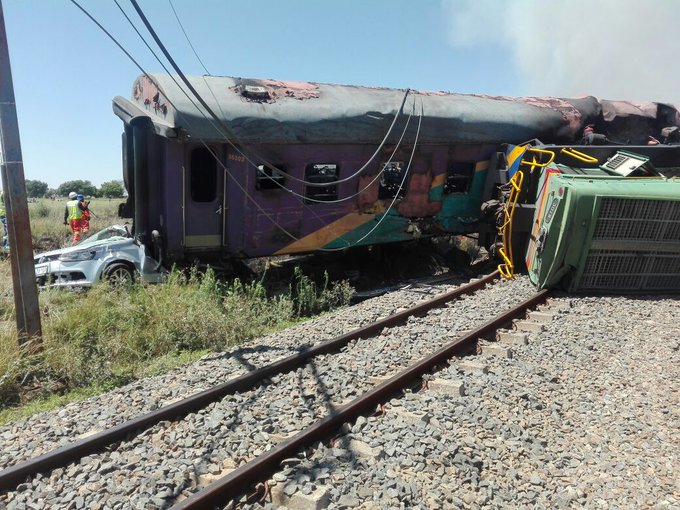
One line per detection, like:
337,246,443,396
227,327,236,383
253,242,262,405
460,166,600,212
0,274,546,508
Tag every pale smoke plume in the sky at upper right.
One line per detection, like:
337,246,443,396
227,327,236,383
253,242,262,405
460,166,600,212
441,0,680,103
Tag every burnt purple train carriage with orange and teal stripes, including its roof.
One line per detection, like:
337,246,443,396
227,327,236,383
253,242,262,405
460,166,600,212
113,74,680,265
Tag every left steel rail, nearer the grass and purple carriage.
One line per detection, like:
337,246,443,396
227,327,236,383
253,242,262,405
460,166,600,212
0,271,498,492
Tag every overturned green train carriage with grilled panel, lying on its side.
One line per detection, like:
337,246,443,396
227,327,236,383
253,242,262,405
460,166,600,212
494,147,680,292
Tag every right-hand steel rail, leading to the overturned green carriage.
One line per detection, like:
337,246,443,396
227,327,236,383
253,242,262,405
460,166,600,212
172,289,549,510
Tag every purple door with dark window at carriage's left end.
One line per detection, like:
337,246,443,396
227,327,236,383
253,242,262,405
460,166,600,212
183,146,226,251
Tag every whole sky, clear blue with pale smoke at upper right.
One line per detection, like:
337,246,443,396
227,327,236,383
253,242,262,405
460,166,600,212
2,0,680,188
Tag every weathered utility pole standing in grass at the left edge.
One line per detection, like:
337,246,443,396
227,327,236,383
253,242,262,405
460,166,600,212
0,0,42,349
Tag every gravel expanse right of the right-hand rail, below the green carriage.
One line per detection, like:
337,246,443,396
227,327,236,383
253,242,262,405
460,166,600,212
274,297,680,508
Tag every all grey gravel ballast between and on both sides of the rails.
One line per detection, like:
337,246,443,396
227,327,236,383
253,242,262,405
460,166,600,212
0,277,680,509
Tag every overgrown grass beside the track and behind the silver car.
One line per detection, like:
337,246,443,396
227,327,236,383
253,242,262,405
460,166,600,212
0,202,351,424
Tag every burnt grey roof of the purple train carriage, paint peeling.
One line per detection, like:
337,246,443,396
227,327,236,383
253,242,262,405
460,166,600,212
113,74,680,144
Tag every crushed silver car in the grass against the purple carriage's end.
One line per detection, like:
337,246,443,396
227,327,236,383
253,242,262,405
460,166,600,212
35,225,162,287
